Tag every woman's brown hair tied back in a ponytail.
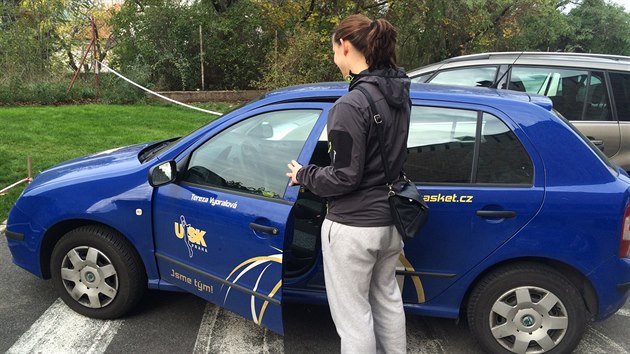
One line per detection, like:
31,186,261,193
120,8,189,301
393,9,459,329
333,15,396,70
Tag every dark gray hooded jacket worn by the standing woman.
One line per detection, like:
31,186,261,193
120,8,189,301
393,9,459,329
297,69,411,227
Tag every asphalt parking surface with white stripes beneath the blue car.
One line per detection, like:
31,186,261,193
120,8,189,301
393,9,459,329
0,228,630,354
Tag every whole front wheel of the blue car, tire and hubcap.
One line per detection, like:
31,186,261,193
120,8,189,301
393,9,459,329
50,226,147,319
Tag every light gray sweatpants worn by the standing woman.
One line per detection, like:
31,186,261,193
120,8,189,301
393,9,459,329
322,219,407,354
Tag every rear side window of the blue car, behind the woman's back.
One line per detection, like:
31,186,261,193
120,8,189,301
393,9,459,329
405,106,533,185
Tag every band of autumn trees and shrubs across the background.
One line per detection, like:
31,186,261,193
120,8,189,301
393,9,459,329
0,0,630,104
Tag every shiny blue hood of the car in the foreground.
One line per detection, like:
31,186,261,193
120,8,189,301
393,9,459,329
27,143,152,194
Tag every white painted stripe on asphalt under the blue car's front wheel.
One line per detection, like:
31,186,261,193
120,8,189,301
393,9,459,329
7,299,124,354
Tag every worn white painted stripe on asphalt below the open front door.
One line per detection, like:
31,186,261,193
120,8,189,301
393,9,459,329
193,303,284,354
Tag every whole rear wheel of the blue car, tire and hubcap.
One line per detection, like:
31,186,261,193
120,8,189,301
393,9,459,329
467,263,587,353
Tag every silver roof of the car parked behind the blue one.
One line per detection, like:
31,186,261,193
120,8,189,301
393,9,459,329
409,52,630,77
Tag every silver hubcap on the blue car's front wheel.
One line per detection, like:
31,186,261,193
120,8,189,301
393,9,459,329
60,246,119,308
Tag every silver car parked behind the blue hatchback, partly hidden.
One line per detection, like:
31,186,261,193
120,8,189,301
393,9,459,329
409,52,630,171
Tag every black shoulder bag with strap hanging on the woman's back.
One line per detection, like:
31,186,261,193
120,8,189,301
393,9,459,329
356,86,429,240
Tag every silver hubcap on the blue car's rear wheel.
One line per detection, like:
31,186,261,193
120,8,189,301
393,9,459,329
489,286,569,353
